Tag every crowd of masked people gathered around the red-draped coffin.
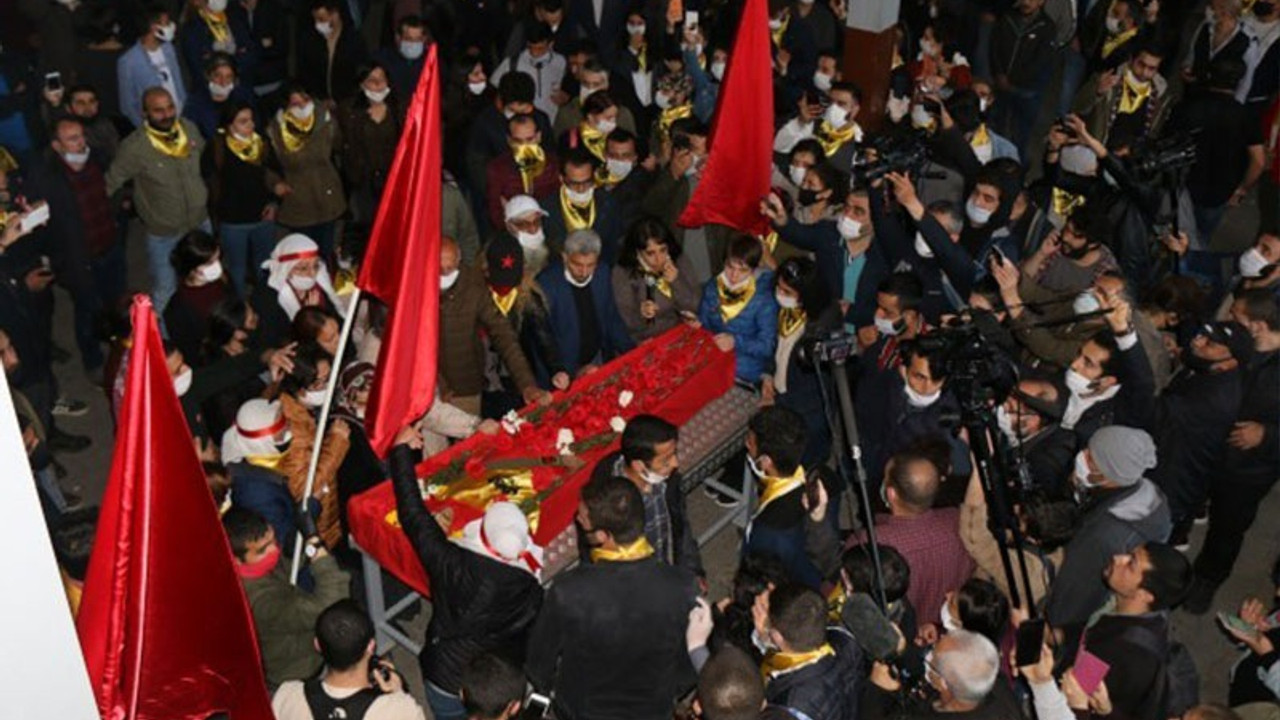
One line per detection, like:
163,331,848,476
0,0,1280,720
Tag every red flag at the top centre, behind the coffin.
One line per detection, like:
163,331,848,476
677,0,773,234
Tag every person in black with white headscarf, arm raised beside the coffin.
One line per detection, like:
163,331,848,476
388,425,543,720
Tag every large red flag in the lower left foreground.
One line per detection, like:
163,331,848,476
77,295,271,720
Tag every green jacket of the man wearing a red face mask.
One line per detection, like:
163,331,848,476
244,555,351,689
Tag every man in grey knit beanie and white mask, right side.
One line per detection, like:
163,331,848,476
1047,425,1171,633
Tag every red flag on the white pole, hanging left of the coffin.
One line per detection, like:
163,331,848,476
356,45,440,456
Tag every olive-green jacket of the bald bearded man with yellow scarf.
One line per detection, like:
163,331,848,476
106,118,209,236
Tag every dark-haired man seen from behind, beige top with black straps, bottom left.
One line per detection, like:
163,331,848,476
271,600,425,720
